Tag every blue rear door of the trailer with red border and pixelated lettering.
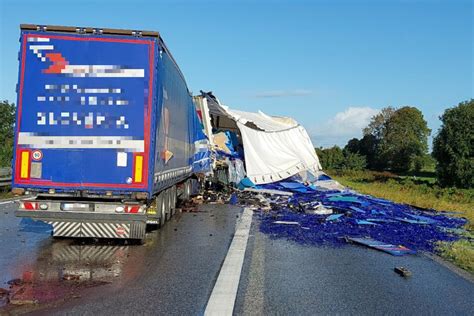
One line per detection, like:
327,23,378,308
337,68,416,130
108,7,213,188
14,31,156,191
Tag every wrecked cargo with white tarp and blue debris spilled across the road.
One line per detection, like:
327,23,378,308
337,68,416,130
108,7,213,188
195,91,466,255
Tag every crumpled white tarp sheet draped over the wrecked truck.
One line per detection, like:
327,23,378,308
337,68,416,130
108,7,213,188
202,91,322,184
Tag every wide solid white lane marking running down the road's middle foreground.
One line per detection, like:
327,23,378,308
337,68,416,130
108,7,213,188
204,208,253,316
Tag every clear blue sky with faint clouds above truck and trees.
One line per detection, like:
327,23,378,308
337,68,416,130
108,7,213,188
0,0,474,147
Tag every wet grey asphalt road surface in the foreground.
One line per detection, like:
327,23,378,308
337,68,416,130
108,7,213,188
0,200,474,315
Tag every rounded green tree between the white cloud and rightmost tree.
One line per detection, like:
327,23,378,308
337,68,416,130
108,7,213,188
378,106,431,172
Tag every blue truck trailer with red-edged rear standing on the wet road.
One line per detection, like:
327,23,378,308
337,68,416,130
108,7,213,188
12,24,209,240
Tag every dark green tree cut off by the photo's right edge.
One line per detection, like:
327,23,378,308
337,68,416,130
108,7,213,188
433,99,474,188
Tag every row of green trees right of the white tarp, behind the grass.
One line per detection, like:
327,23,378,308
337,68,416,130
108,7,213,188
316,99,474,188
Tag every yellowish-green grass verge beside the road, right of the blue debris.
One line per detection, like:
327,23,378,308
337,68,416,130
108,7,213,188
328,170,474,273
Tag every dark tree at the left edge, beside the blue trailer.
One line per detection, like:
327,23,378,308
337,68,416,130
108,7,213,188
0,100,15,167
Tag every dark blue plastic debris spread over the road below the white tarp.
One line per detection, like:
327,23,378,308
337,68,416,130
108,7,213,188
258,181,467,252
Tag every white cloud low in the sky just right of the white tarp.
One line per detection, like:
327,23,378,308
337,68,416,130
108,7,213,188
310,107,380,147
